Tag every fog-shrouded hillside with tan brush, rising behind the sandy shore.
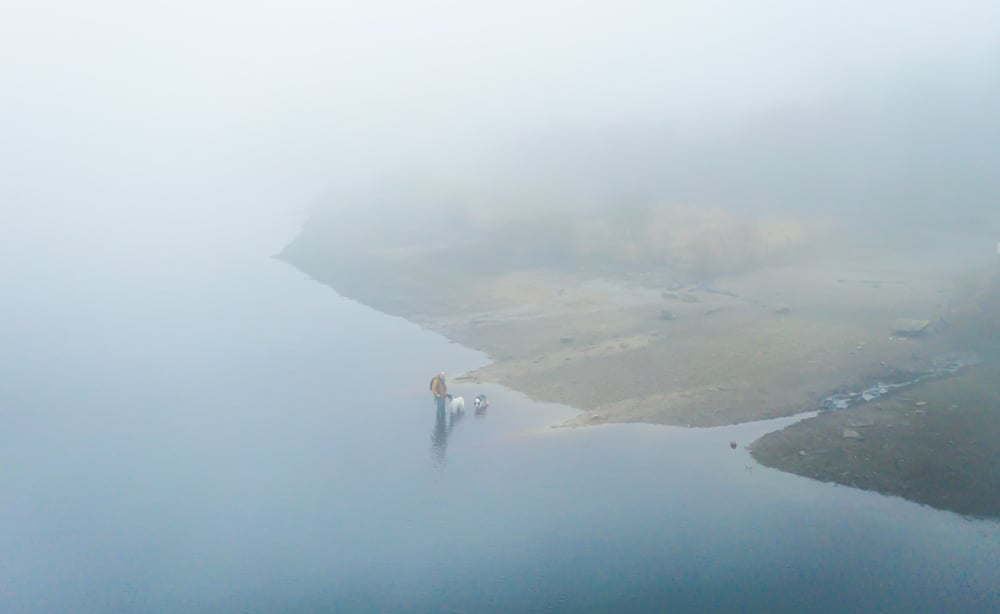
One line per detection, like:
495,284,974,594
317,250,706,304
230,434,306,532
286,66,1000,277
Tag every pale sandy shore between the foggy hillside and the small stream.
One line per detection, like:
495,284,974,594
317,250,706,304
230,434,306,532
274,233,984,427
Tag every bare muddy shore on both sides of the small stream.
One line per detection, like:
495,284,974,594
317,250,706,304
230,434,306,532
278,229,1000,517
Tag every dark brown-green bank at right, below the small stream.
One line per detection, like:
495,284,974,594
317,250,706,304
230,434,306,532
748,363,1000,519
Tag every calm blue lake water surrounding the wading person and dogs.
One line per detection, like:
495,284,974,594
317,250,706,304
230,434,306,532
0,232,1000,612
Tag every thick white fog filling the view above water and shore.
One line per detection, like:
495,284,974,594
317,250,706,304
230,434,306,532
0,1,1000,254
